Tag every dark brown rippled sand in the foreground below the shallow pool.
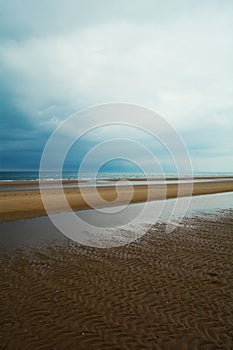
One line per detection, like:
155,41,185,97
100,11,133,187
0,210,233,350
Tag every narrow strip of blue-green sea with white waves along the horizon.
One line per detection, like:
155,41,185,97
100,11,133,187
0,171,233,182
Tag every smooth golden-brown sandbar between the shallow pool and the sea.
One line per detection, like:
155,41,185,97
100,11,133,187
0,179,233,222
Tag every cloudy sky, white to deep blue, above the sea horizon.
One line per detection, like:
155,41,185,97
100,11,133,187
0,0,233,172
